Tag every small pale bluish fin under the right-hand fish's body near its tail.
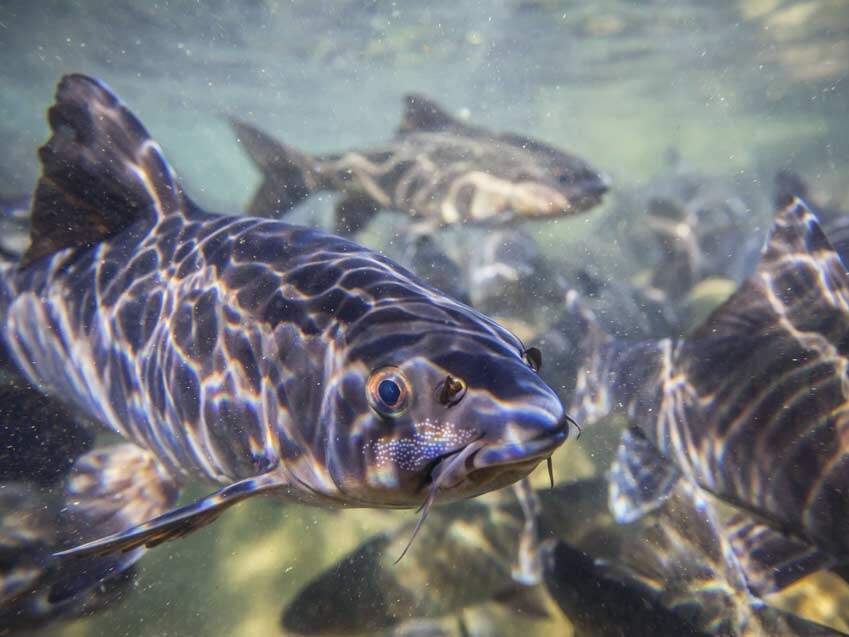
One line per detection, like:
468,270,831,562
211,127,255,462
608,429,681,524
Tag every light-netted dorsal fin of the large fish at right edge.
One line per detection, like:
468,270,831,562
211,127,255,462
692,197,849,339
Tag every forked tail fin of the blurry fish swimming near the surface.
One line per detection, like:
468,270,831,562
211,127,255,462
230,117,321,217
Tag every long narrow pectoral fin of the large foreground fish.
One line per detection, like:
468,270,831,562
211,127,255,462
55,472,286,557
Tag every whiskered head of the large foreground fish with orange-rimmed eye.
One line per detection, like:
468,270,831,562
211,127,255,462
331,303,568,507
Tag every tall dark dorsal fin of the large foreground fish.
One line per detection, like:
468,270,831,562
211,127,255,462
23,75,184,263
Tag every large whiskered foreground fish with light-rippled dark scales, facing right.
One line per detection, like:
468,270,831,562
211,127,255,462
0,74,569,600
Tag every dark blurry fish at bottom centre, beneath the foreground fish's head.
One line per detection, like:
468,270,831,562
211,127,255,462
281,480,610,637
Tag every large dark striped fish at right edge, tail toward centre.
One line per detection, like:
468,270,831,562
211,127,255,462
567,198,849,597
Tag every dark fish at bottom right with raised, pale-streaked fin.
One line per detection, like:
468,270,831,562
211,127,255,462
576,480,843,637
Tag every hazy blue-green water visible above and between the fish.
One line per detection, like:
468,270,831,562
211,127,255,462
0,0,849,636
